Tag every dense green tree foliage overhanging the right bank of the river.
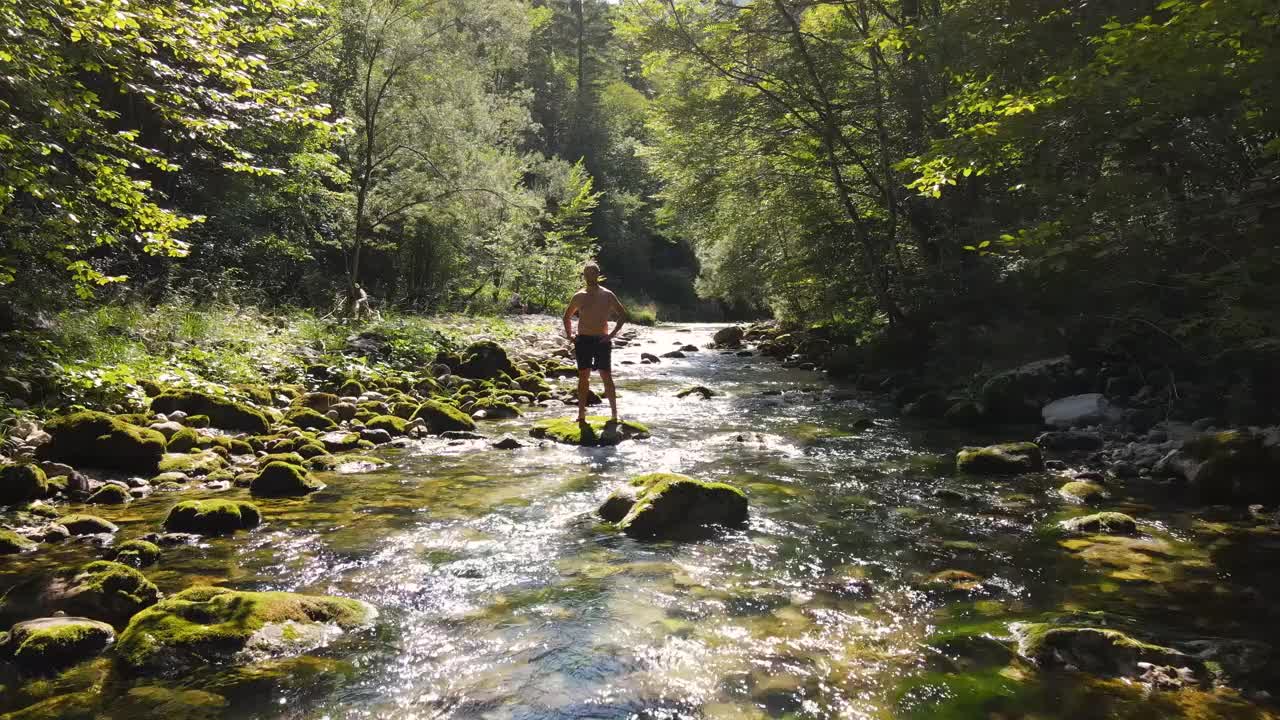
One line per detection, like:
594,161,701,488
623,0,1280,415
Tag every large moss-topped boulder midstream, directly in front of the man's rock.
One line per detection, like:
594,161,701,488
617,473,748,539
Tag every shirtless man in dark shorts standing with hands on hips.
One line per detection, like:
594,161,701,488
564,263,627,423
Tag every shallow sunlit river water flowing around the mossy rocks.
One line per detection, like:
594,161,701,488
0,325,1280,719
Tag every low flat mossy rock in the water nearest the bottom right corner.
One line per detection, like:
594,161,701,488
1014,623,1194,676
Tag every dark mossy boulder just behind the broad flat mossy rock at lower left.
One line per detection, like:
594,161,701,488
45,560,160,625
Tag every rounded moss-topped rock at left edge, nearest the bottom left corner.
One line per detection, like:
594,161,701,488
0,616,115,674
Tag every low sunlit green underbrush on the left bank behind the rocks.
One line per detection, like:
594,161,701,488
0,301,529,423
